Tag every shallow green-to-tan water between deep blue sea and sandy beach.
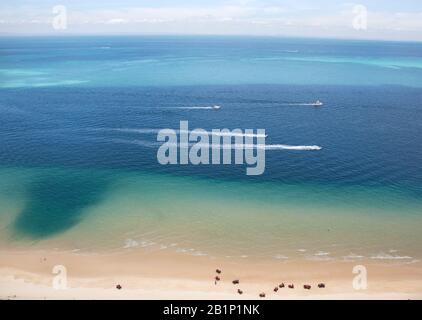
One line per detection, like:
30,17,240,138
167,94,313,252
0,168,422,262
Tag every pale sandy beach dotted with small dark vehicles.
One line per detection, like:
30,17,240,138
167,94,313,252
0,251,422,300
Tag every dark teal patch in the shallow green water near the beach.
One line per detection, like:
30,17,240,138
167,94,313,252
14,170,108,239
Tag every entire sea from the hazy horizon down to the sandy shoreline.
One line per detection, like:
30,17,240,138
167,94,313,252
0,37,422,262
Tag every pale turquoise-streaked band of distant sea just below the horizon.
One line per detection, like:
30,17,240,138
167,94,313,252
0,37,422,88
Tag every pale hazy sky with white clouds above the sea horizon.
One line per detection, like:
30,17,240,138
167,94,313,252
0,0,422,41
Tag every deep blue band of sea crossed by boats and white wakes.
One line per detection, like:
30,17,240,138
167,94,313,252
0,85,422,193
